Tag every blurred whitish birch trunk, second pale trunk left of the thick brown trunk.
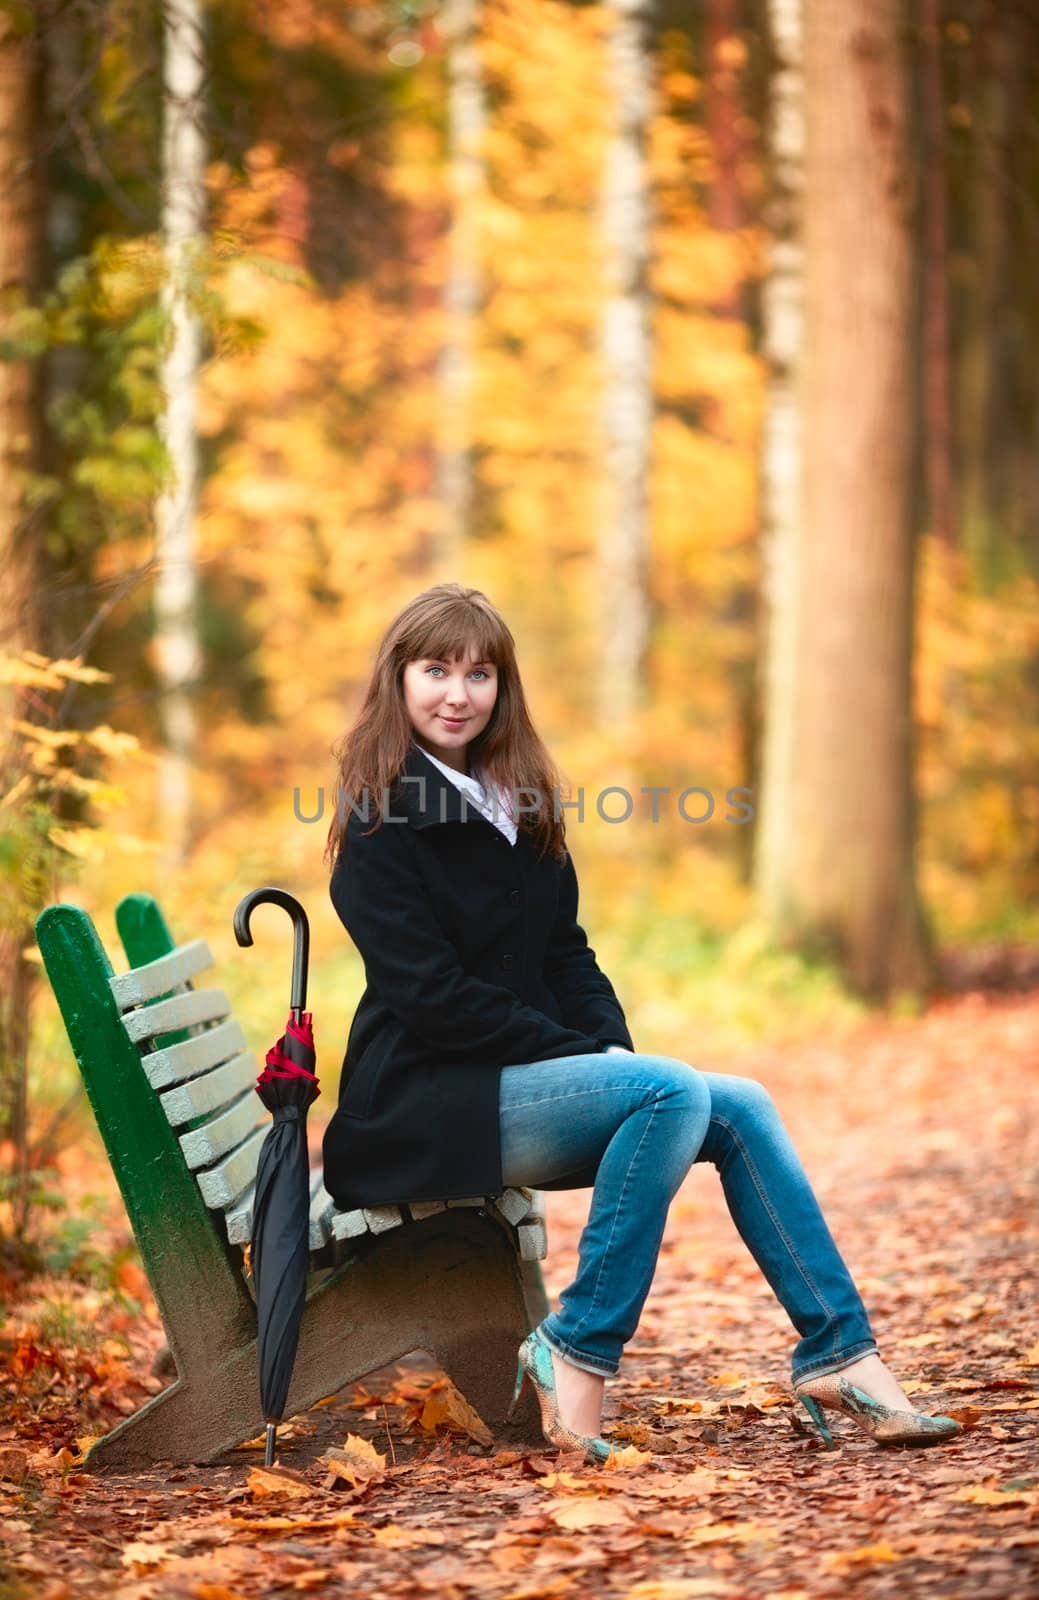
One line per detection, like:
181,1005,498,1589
596,0,653,731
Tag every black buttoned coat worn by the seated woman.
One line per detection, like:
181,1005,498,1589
323,746,632,1210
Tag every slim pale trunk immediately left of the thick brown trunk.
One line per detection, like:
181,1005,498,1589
754,0,805,928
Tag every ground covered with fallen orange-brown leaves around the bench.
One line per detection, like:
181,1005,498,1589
0,992,1039,1600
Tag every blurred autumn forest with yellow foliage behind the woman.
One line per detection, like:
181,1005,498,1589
0,0,1039,1260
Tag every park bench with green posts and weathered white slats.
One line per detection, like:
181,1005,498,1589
37,894,548,1469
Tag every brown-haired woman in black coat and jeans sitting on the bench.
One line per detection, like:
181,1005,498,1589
325,584,961,1461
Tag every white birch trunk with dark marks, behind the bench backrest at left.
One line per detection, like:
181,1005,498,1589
155,0,205,867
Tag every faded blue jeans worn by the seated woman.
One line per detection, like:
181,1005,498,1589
499,1054,877,1382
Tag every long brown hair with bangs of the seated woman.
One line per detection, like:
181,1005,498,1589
325,584,565,866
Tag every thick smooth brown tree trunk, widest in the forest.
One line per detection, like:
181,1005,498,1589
789,0,929,997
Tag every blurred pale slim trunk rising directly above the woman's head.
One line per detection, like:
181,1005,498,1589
434,0,485,578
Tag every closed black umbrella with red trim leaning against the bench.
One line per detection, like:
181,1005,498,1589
234,888,319,1467
